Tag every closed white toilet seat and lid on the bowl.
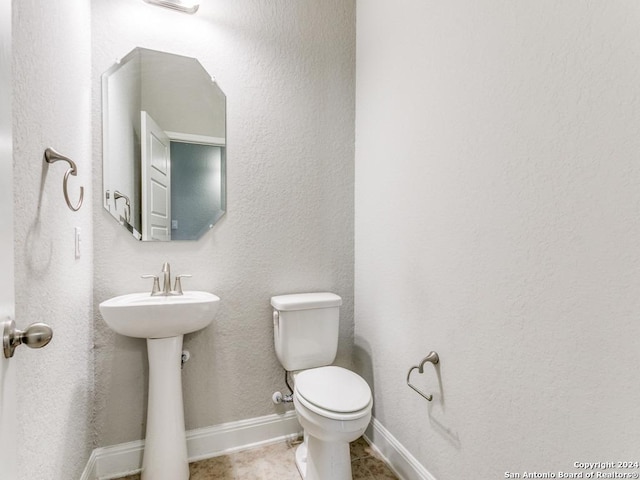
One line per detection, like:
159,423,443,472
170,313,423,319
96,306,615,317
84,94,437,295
294,366,372,420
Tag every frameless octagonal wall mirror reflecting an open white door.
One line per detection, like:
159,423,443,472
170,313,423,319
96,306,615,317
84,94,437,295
102,48,227,241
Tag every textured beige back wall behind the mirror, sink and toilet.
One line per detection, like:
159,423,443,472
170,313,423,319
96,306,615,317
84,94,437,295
91,0,355,446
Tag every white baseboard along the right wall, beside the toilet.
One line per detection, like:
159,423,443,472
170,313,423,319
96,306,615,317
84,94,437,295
364,418,436,480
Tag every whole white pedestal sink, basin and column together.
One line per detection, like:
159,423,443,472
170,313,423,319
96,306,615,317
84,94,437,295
100,291,220,480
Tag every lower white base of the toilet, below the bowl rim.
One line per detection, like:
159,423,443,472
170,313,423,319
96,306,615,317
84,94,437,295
296,433,353,480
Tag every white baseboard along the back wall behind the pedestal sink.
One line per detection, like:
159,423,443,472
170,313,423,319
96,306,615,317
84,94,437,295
80,410,302,480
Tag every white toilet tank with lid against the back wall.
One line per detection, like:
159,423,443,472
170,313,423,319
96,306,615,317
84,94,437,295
271,292,342,372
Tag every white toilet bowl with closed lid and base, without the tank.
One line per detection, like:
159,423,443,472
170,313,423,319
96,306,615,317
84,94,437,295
293,366,373,480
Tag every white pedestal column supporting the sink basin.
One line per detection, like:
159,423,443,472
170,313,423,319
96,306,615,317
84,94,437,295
142,335,189,480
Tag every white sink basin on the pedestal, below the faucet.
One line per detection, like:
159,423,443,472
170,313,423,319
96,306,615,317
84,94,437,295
100,291,220,338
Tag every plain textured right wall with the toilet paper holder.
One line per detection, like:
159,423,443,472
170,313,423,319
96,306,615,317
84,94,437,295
355,0,640,480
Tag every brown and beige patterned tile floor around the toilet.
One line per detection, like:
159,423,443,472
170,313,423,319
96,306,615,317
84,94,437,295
114,438,398,480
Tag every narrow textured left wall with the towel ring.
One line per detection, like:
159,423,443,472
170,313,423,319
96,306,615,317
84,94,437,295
12,0,93,480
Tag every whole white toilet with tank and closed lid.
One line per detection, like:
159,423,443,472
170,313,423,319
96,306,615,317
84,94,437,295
271,293,373,480
